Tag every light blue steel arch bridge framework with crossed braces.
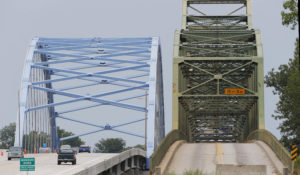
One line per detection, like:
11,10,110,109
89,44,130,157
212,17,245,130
15,37,165,164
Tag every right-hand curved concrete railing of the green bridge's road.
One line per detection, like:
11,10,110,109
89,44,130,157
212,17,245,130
247,129,293,172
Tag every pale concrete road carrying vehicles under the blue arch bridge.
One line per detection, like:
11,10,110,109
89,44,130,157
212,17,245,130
0,151,118,175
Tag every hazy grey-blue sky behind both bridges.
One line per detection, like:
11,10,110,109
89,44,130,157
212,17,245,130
0,0,297,148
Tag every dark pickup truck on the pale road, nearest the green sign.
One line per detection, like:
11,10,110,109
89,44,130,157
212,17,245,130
57,145,76,165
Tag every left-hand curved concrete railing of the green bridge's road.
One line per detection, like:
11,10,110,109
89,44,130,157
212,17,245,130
150,130,186,172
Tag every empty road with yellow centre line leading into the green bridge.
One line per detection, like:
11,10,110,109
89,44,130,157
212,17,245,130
167,141,284,175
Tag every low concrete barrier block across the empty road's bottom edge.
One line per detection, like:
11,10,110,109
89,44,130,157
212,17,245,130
216,164,267,175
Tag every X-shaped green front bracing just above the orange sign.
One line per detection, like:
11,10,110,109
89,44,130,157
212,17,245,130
179,60,257,95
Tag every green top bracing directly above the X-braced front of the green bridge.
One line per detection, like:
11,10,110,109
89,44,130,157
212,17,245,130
179,30,257,57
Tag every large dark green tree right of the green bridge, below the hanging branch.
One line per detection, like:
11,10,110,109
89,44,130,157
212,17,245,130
265,39,300,148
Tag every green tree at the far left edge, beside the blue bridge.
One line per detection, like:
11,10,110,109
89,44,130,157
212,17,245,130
0,123,16,149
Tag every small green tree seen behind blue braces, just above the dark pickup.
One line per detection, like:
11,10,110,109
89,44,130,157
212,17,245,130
57,127,85,147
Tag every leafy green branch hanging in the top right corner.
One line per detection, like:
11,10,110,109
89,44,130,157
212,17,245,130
281,0,299,30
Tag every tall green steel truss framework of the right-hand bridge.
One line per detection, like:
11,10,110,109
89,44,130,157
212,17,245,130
173,0,264,142
